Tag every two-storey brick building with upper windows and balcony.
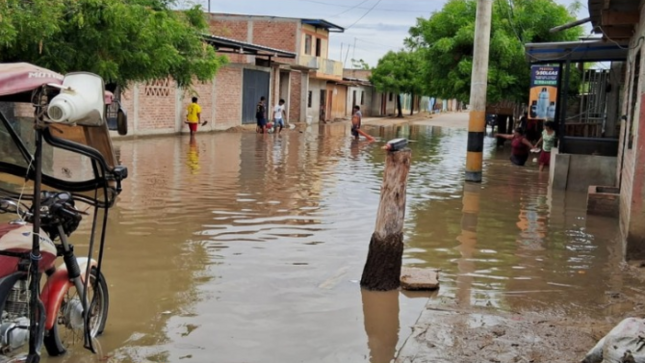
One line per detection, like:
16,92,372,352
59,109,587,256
210,14,347,122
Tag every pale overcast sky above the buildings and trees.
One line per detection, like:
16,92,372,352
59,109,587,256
192,0,589,67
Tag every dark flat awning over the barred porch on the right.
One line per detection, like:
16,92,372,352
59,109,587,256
525,40,629,63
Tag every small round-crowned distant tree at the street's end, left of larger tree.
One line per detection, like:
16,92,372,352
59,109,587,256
370,50,424,117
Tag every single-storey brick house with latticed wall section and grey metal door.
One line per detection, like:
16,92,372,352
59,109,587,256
114,36,299,135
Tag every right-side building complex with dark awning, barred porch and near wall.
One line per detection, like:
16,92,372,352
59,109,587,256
526,0,645,259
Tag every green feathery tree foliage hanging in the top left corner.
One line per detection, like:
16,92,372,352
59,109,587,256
0,0,227,86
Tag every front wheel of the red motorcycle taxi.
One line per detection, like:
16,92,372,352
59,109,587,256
43,268,110,357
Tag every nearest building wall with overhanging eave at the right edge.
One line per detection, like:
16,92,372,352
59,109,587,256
589,0,645,259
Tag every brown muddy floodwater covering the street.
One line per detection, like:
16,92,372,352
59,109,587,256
39,125,633,363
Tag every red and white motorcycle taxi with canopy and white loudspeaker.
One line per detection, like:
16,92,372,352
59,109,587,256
0,63,127,363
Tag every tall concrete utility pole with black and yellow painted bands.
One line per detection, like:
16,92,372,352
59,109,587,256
466,0,493,183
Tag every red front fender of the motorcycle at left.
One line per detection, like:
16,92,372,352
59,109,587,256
40,257,98,331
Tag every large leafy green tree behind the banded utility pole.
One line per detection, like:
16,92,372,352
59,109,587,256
406,0,582,103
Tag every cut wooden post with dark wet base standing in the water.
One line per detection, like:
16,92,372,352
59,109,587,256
361,139,412,291
